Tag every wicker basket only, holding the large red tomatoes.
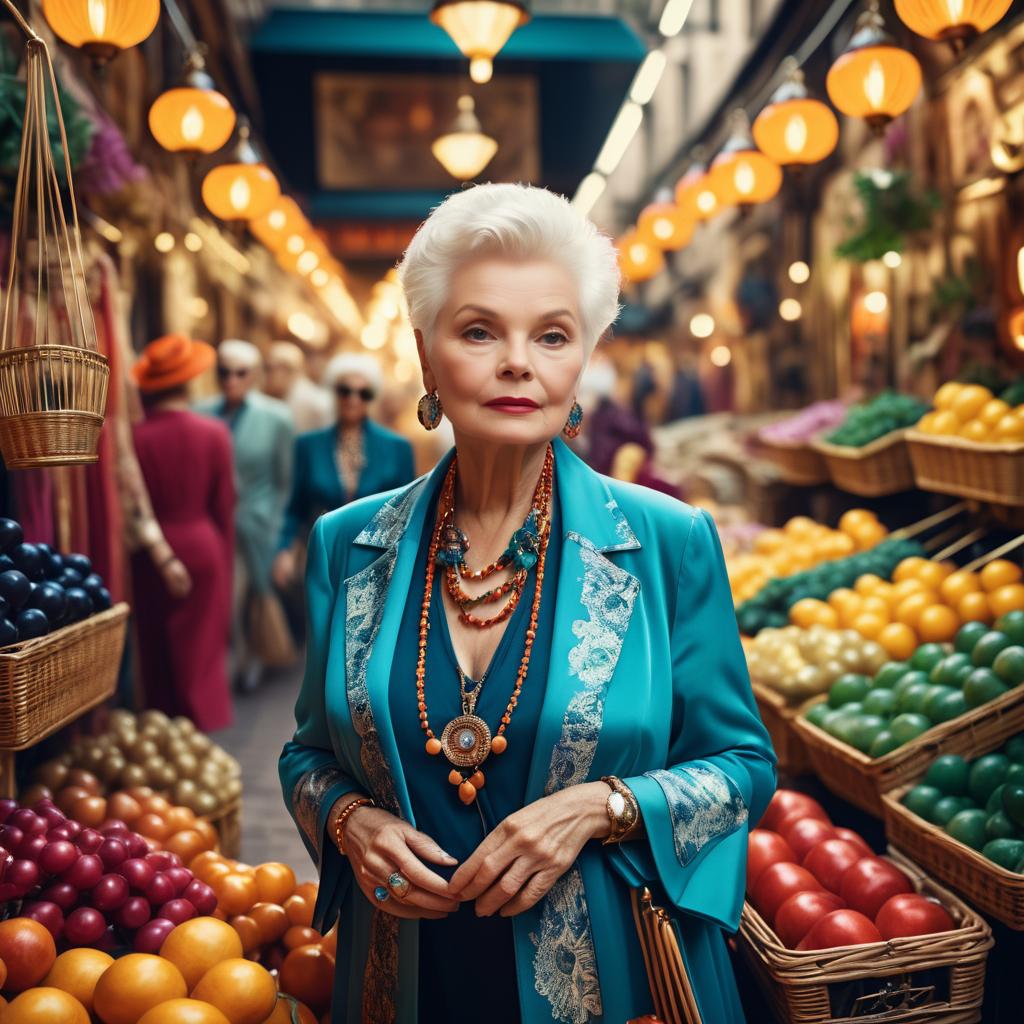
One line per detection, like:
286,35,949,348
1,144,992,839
737,850,992,1024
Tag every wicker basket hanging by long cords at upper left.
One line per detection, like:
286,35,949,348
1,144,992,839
0,23,110,469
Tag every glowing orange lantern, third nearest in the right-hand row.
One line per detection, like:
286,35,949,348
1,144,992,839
754,57,839,167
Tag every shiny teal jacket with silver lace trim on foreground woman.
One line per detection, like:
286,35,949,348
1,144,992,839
281,440,775,1024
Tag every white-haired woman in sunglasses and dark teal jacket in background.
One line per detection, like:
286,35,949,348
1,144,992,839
273,352,416,588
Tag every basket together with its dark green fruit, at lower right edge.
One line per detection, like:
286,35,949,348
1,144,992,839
883,735,1024,931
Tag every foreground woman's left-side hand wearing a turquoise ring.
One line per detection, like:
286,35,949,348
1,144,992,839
331,807,459,919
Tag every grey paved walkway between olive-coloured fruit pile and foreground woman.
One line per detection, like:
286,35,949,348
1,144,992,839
214,666,315,879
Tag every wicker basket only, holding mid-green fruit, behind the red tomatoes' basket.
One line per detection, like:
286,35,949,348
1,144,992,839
793,686,1024,818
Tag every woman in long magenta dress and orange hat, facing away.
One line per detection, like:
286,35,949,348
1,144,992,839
131,335,234,732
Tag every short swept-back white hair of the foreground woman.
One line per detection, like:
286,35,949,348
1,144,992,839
398,184,620,355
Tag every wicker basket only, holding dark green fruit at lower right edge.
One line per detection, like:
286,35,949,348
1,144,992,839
882,782,1024,932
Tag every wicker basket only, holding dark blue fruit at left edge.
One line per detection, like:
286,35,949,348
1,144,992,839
0,604,128,751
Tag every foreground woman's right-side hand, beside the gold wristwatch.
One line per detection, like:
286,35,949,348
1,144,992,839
449,782,610,918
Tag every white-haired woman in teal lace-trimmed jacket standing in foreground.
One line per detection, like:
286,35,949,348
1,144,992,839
281,184,775,1024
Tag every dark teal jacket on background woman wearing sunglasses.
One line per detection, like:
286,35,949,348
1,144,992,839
278,420,415,549
